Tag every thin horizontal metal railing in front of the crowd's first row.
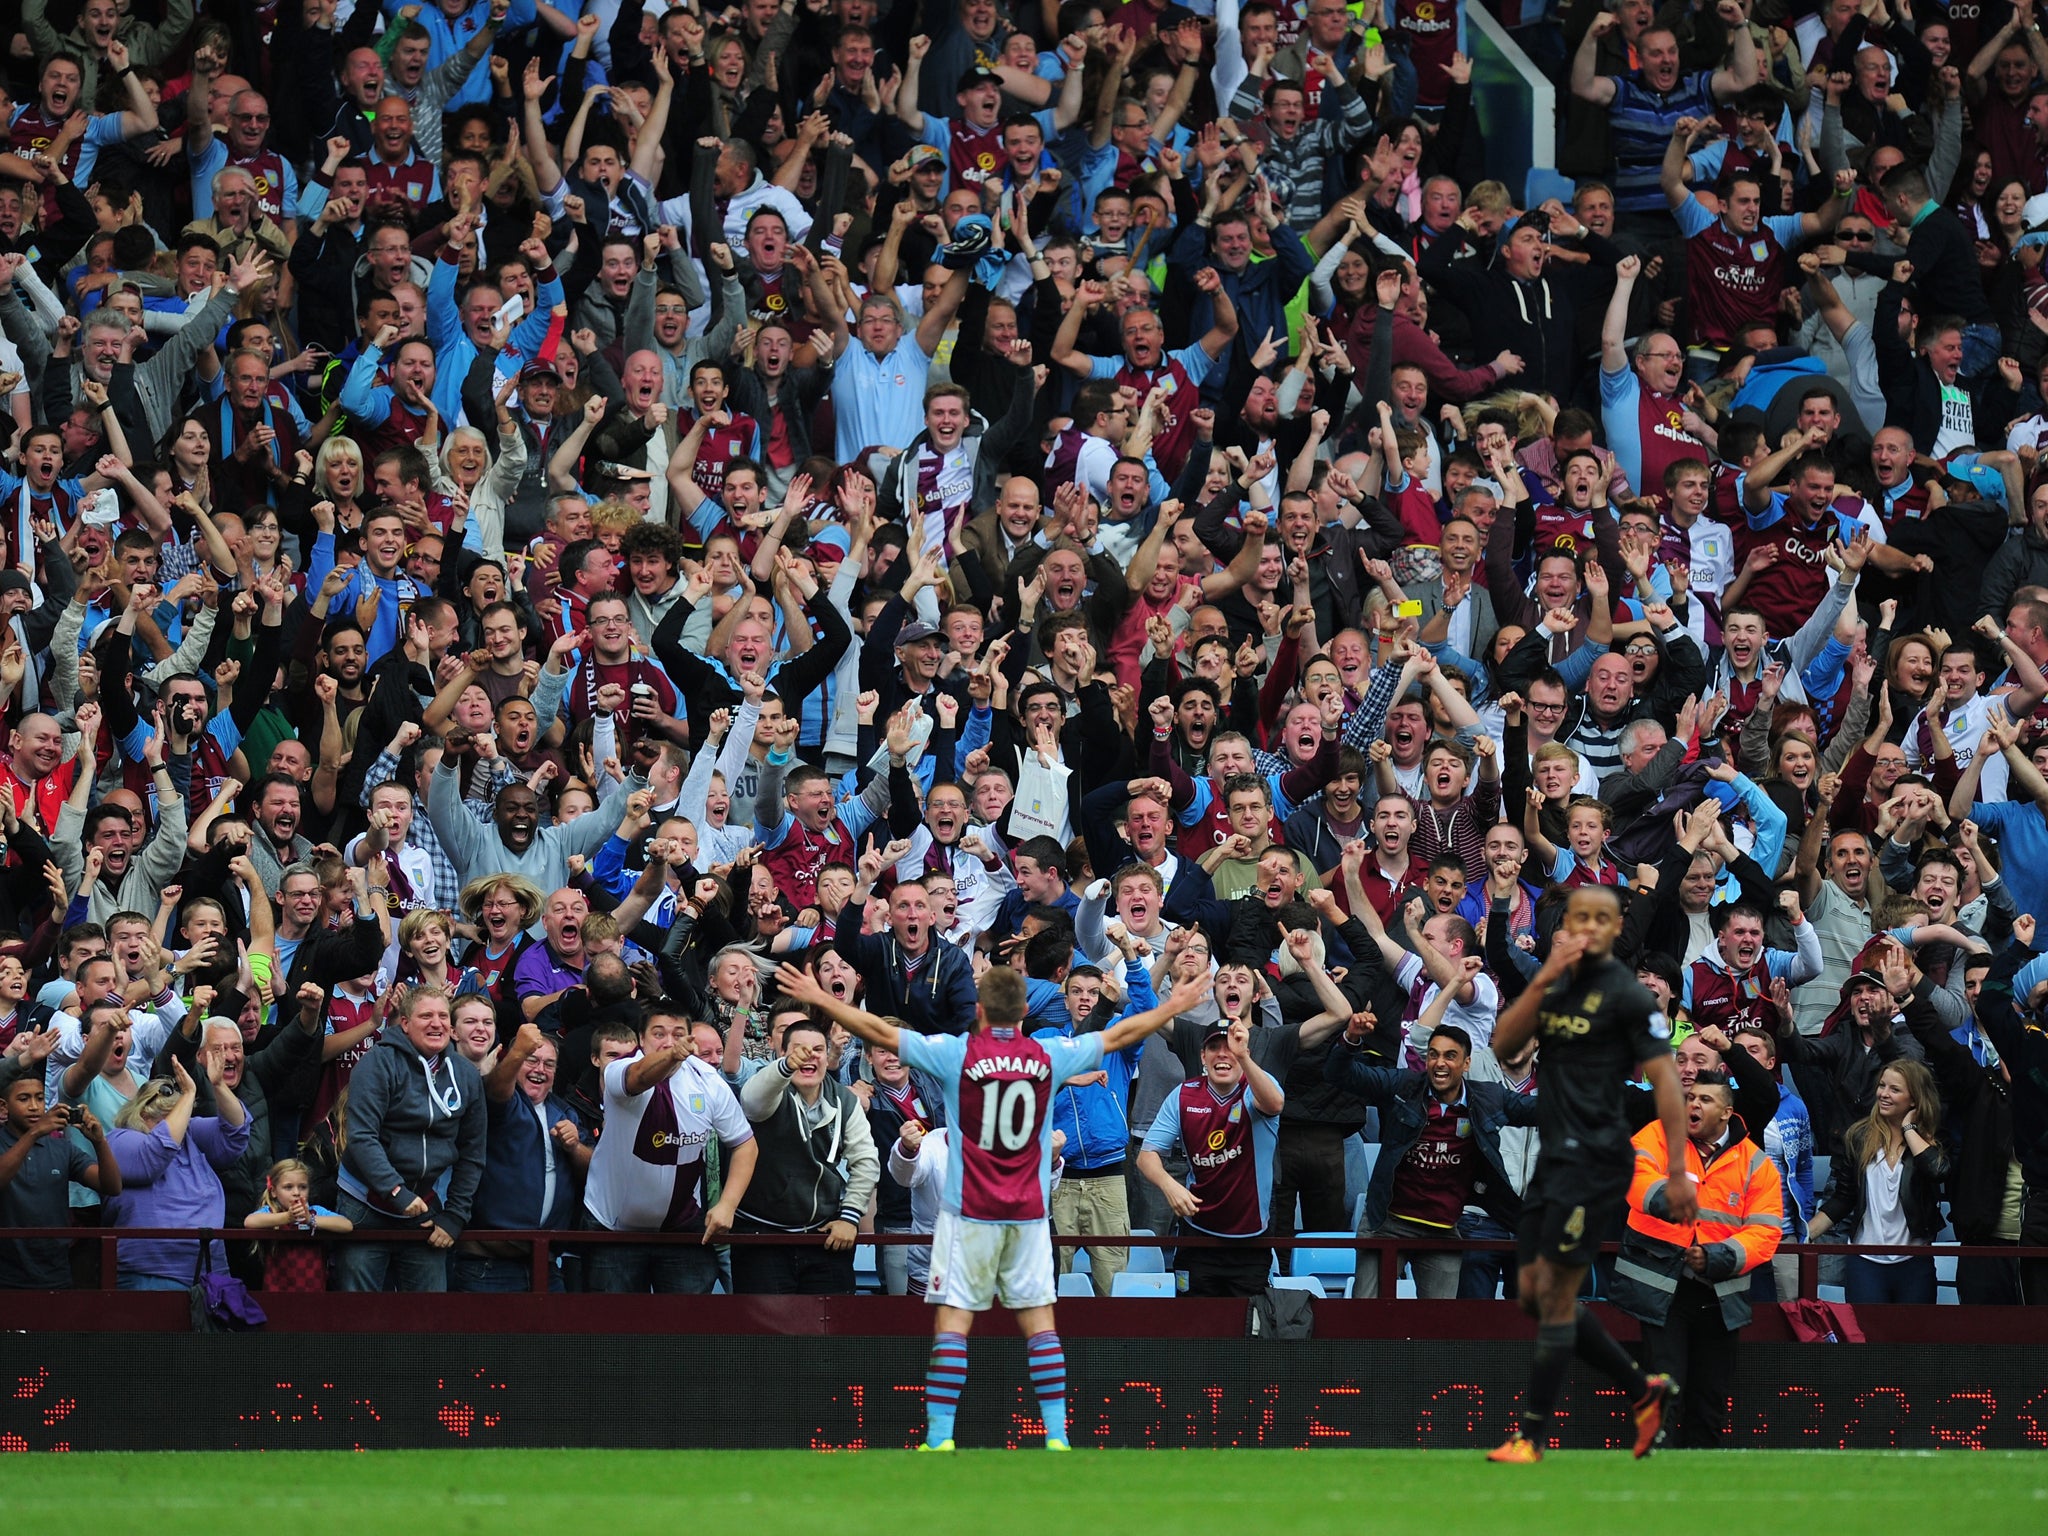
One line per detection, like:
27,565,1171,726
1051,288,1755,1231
0,1227,2048,1300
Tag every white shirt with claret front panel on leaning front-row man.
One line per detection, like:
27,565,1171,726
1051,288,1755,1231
584,1055,754,1233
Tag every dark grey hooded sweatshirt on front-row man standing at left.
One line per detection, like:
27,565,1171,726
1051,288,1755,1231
340,1028,487,1237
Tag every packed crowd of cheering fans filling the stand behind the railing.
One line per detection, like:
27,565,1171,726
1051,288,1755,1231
0,0,2048,1343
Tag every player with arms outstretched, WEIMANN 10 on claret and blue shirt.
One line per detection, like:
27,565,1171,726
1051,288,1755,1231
776,965,1210,1450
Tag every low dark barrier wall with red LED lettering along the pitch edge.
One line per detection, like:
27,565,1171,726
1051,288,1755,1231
16,1233,2048,1452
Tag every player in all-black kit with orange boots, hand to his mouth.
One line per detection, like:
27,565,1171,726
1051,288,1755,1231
1487,885,1698,1464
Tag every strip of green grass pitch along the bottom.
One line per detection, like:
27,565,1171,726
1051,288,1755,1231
0,1458,2048,1536
